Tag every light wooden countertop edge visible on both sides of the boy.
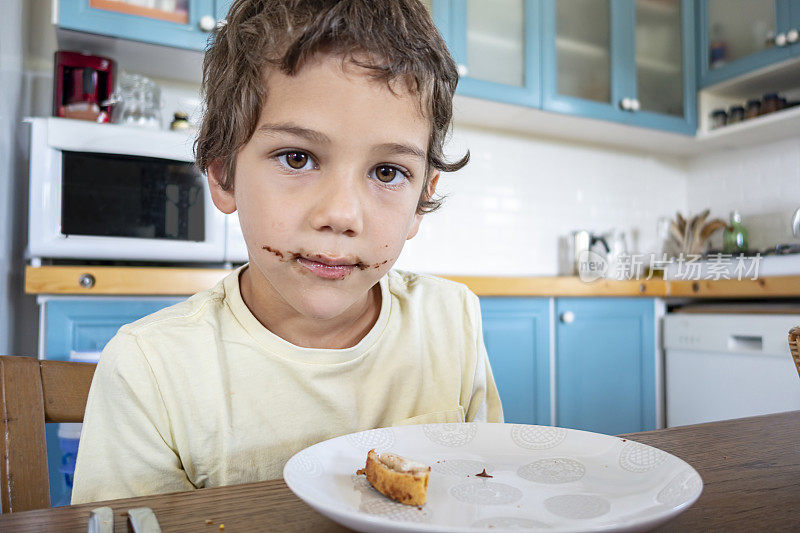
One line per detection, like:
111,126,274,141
25,266,800,298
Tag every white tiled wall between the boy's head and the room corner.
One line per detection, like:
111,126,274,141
397,127,687,275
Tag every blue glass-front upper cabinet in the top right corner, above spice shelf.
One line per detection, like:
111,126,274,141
696,0,800,88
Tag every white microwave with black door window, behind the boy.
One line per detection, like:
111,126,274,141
27,118,247,262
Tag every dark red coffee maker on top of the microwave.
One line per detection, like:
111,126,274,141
53,50,116,122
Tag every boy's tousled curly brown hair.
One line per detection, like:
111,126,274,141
195,0,469,213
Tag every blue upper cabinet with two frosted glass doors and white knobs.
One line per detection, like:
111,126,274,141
542,0,697,135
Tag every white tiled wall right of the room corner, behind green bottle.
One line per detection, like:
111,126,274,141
686,135,800,249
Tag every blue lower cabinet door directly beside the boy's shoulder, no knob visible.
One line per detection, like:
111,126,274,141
481,297,551,425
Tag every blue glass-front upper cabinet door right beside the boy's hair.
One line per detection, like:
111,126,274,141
423,0,541,107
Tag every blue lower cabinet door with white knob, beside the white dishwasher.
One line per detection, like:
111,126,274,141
555,298,657,435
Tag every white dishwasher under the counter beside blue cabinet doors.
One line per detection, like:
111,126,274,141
664,312,800,427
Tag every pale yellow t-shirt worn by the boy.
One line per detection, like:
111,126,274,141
72,269,503,503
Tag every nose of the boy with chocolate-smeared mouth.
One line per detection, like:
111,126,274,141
310,174,364,237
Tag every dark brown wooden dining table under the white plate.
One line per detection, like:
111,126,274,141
0,411,800,533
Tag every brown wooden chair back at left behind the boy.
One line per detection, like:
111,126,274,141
0,355,97,513
